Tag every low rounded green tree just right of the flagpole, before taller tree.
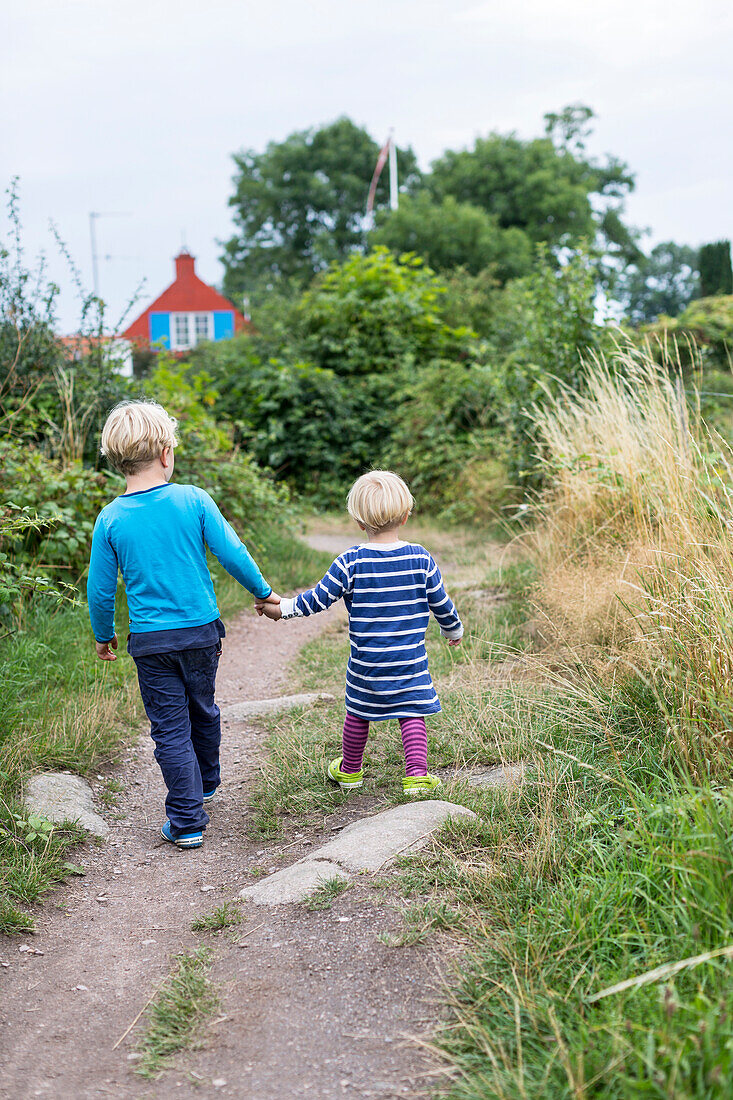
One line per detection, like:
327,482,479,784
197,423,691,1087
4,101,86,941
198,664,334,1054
370,191,532,283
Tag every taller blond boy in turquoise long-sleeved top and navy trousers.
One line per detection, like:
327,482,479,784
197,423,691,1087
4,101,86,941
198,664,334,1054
87,402,278,848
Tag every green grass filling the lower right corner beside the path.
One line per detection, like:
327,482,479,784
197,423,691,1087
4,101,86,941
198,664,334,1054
387,677,733,1100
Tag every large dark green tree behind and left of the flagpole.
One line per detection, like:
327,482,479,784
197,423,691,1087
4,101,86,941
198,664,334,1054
222,118,419,297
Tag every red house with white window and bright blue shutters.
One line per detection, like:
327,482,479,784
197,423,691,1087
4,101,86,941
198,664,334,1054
122,249,249,351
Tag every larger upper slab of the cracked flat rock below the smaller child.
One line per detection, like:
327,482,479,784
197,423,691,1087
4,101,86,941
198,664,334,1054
309,799,475,871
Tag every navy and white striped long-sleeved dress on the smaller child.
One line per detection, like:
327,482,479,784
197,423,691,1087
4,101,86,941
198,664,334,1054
281,542,463,722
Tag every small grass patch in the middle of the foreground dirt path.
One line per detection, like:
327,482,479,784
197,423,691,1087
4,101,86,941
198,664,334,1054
135,947,219,1077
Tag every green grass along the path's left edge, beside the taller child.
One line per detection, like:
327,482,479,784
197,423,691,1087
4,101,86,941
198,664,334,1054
0,602,140,934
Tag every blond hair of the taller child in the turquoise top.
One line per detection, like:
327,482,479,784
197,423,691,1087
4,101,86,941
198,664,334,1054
101,402,178,475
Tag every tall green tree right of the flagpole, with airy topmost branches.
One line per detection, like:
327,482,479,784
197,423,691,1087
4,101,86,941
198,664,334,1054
427,105,636,270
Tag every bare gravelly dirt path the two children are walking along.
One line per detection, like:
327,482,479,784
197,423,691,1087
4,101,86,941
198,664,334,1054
0,531,451,1100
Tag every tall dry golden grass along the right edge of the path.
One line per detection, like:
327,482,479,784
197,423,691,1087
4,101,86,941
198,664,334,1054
535,338,733,778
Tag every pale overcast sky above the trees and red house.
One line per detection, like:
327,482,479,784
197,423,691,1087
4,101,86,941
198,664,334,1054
0,0,733,329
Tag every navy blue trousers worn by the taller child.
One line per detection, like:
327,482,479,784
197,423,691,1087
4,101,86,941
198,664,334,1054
133,645,221,836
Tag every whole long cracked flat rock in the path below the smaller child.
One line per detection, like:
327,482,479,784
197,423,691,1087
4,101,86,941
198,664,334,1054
240,799,475,905
